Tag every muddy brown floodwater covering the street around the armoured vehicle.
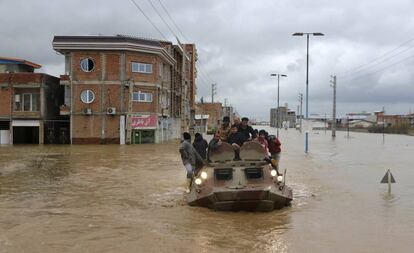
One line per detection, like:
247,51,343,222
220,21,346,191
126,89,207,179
0,129,414,253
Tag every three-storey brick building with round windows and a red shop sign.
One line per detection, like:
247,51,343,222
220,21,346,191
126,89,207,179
53,35,195,144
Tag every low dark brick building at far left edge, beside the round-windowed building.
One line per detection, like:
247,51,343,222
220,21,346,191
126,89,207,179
0,57,69,144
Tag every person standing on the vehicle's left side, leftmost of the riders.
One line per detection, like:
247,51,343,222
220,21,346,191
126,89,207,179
179,132,204,193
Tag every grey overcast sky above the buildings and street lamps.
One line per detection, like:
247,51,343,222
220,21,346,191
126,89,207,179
0,0,414,119
